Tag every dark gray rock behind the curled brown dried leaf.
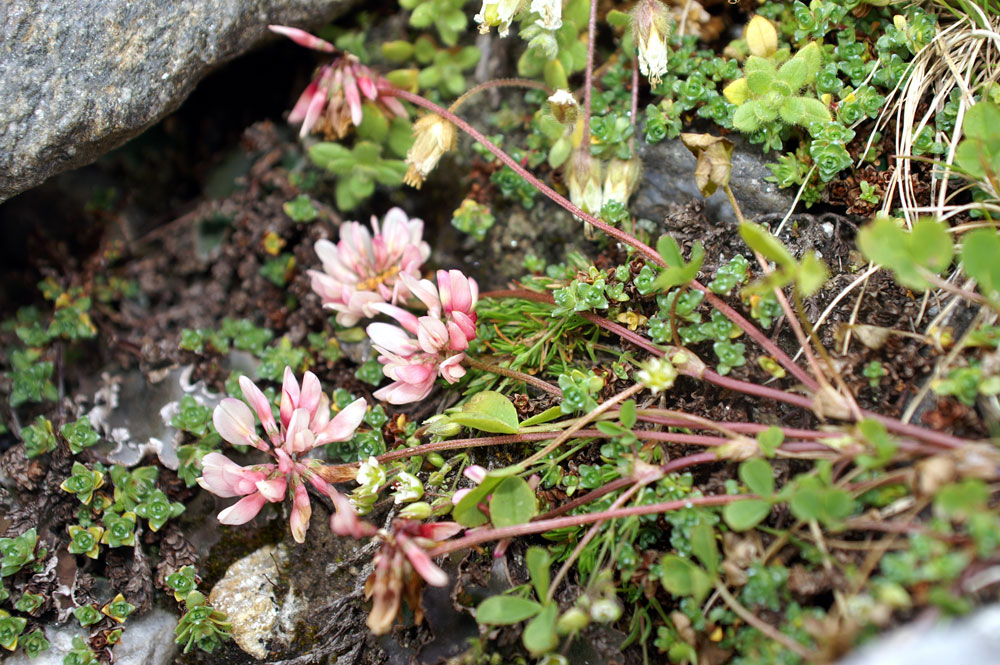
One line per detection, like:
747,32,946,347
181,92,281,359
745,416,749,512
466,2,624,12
632,135,795,223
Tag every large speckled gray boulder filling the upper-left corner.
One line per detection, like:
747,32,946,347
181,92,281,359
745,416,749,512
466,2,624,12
0,0,356,202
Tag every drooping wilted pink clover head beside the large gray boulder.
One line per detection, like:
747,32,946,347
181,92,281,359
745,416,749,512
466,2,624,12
268,25,409,139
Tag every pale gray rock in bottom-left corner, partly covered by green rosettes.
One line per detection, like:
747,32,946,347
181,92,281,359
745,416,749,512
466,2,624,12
4,608,177,665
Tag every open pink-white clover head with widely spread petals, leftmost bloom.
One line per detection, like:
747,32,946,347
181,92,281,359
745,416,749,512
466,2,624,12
198,367,367,543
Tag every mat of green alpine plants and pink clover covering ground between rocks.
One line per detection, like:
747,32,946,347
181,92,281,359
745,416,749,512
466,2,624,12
0,0,1000,665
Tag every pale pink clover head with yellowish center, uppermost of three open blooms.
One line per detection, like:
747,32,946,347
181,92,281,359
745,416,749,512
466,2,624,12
308,208,431,326
